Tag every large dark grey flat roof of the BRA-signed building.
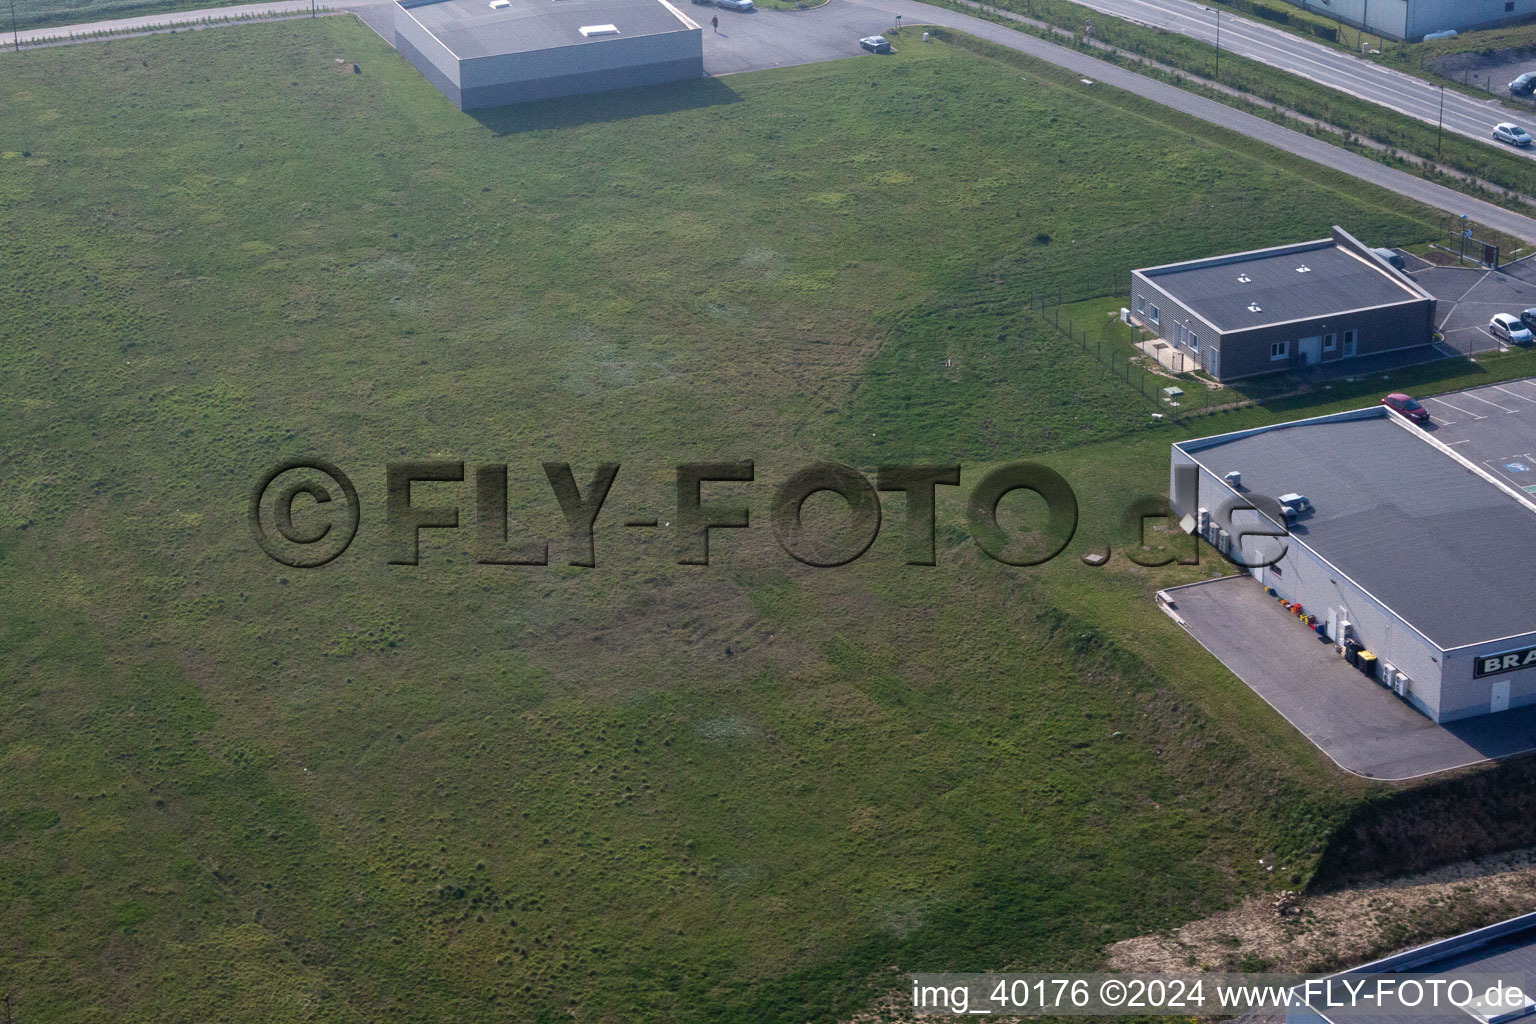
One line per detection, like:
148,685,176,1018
1178,410,1536,649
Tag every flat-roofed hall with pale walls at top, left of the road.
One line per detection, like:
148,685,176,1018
395,0,703,111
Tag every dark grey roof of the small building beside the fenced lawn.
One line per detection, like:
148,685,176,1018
1138,239,1427,332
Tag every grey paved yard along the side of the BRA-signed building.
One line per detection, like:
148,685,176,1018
1164,574,1536,780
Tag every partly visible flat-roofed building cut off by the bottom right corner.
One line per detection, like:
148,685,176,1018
1286,913,1536,1024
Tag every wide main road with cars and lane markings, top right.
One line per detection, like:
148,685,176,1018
1077,0,1536,160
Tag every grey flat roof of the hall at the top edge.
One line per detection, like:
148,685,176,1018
399,0,697,60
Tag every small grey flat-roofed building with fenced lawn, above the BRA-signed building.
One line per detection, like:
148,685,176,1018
1130,227,1435,381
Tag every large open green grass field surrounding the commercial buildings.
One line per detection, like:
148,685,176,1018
0,18,1524,1024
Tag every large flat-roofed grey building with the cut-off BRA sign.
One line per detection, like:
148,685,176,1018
1170,405,1536,722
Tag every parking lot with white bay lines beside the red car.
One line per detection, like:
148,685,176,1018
1422,378,1536,494
